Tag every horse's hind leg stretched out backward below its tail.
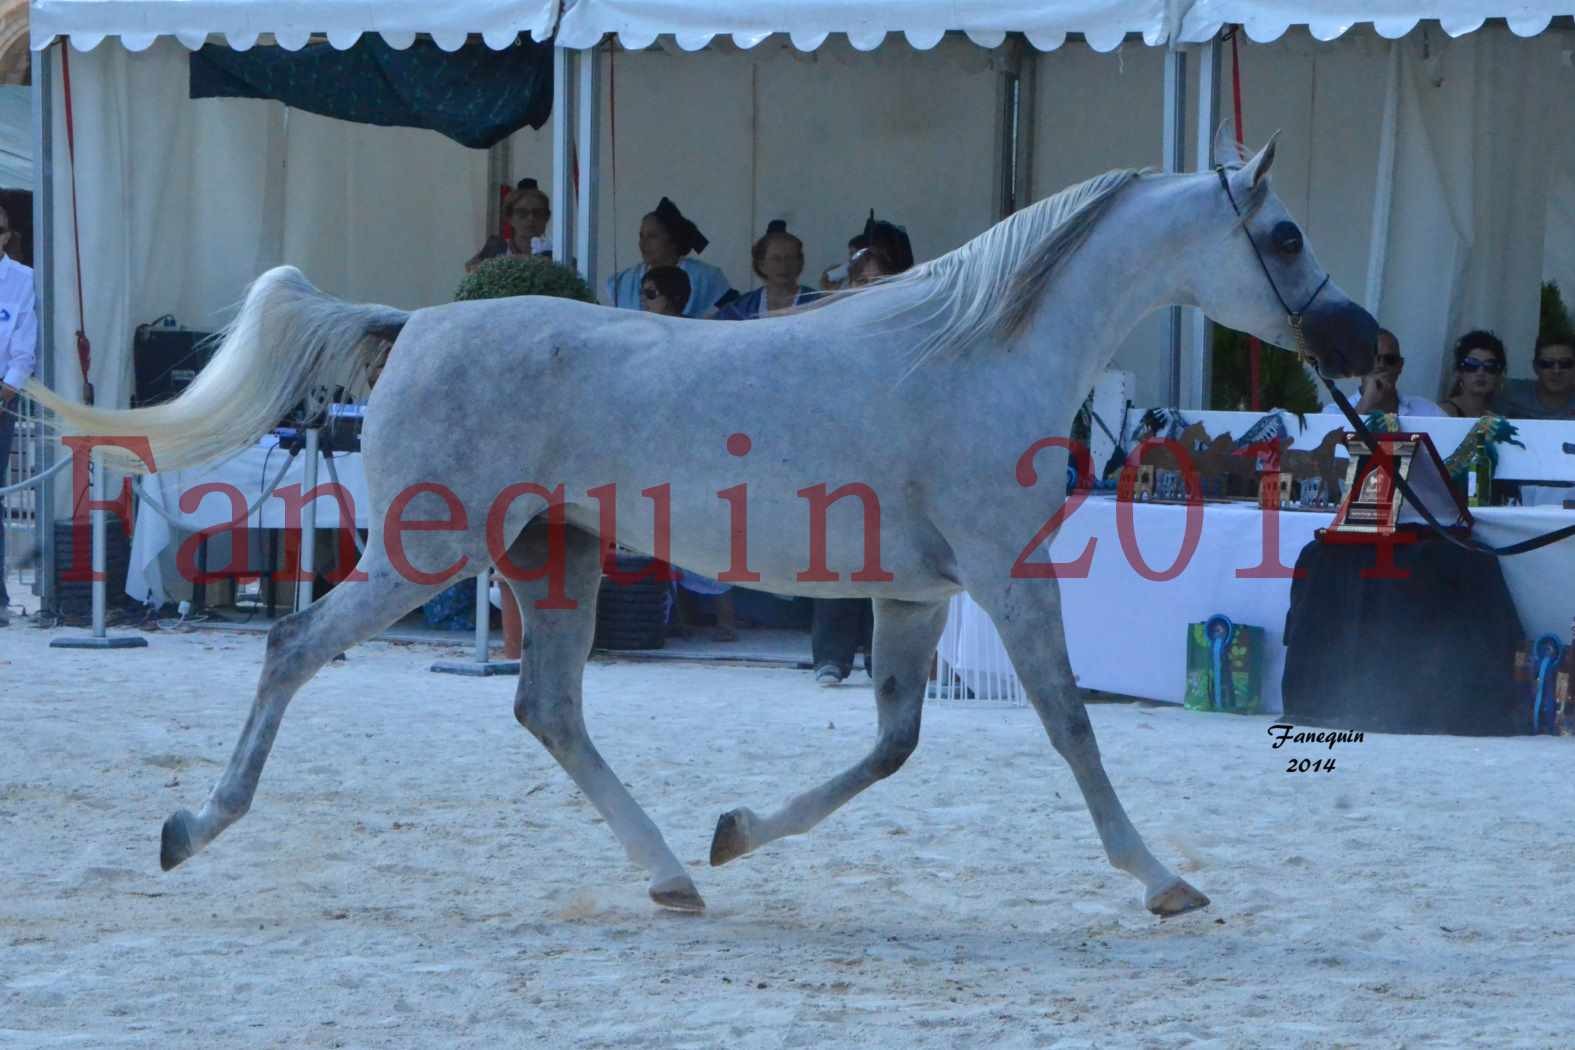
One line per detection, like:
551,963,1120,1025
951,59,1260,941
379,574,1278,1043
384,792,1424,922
159,546,443,871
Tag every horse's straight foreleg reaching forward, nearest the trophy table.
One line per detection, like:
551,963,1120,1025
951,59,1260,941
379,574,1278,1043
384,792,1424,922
967,571,1208,916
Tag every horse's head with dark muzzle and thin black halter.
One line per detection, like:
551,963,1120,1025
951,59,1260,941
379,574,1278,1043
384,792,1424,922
1192,140,1378,378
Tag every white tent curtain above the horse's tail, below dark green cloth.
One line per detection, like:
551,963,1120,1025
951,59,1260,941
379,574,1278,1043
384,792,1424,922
52,41,488,418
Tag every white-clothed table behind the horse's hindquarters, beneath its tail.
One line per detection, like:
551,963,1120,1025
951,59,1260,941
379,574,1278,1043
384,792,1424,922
126,436,369,604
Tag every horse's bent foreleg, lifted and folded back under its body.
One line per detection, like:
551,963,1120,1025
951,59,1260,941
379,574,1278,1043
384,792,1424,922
710,600,947,864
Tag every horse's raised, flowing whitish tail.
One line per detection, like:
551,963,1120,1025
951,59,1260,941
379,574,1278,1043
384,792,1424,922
24,266,410,474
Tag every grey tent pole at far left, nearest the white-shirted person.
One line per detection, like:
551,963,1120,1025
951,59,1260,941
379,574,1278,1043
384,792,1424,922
33,39,56,609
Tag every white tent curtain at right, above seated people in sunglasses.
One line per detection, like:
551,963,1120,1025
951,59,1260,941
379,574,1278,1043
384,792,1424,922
1369,33,1569,398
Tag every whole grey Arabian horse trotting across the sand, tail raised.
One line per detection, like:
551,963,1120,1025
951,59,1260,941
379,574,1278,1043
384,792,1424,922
28,145,1377,916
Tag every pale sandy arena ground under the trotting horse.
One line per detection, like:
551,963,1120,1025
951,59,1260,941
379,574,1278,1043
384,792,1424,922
0,623,1575,1050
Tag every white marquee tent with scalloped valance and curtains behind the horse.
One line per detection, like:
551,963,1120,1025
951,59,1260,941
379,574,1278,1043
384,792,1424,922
21,0,1575,604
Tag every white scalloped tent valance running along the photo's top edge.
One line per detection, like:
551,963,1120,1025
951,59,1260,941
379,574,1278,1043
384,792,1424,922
21,0,1575,52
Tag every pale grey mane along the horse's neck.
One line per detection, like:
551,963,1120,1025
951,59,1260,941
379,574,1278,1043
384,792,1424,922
811,168,1148,368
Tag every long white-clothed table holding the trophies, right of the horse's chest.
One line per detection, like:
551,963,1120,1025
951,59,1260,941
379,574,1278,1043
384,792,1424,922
942,494,1575,712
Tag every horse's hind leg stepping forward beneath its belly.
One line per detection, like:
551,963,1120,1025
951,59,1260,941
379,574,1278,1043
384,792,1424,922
509,521,706,911
